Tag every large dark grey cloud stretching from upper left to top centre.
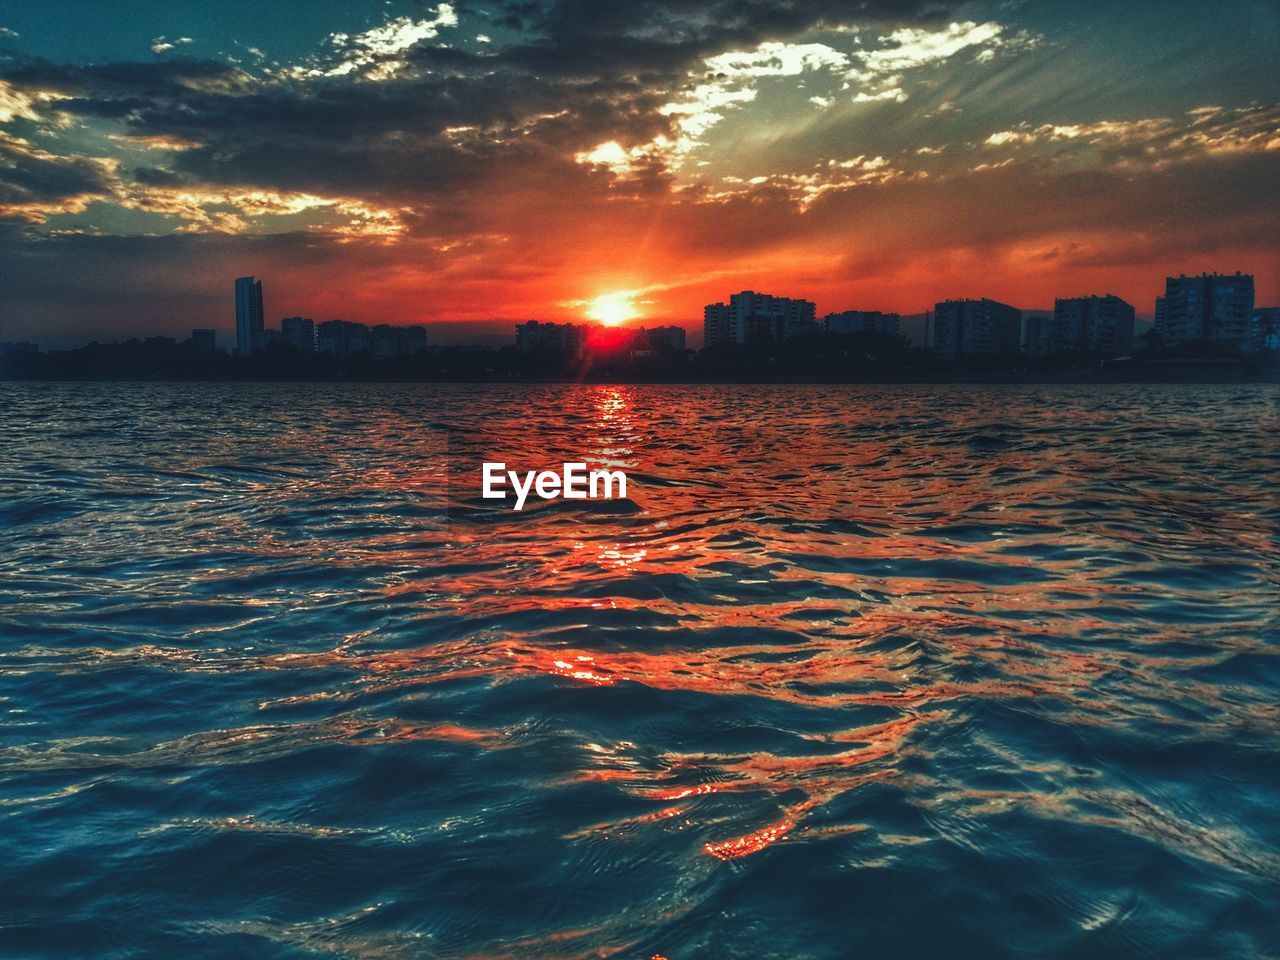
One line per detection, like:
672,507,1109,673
0,0,950,202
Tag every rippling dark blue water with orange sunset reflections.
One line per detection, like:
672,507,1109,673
0,384,1280,960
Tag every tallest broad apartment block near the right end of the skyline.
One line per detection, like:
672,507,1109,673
1156,273,1253,352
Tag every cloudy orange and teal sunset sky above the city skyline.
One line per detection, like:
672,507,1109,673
0,0,1280,346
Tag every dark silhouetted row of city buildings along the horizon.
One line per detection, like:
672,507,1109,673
0,264,1280,361
